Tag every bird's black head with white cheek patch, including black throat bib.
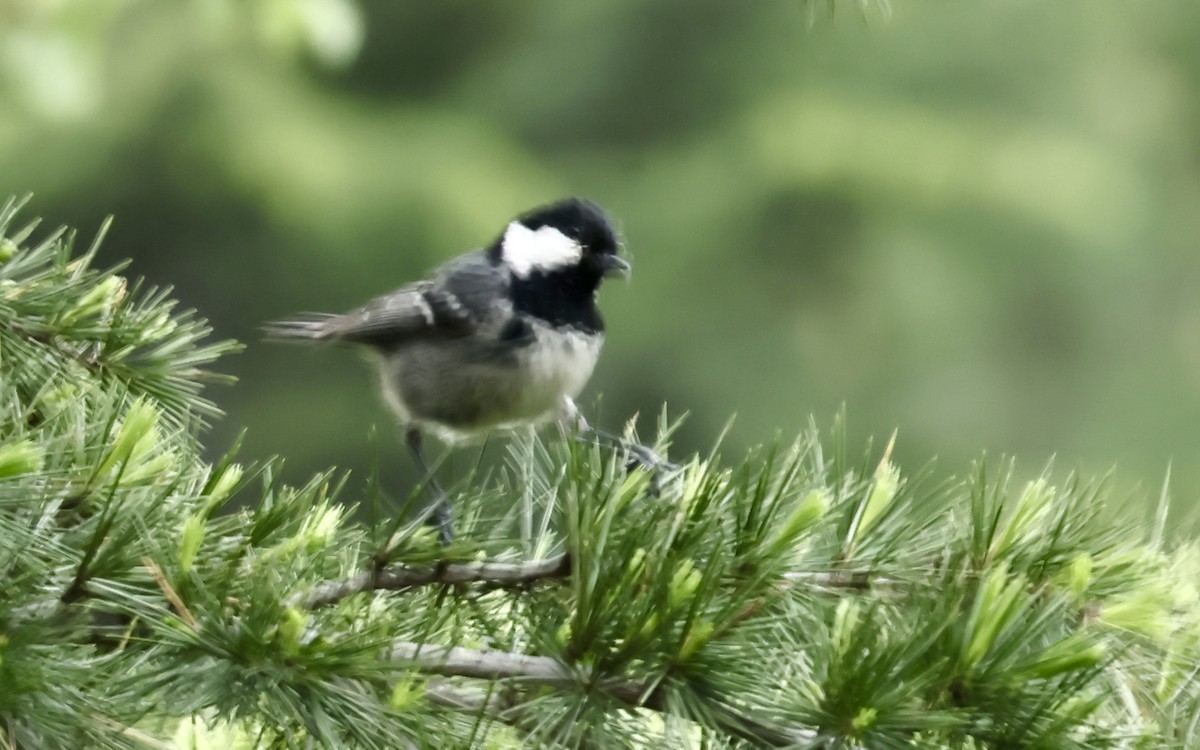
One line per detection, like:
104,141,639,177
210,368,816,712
490,198,630,332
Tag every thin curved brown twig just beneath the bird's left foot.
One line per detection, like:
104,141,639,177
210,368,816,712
289,554,571,610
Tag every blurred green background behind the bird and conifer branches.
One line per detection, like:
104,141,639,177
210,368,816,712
0,0,1200,520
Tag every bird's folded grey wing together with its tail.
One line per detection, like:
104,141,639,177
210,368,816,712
266,252,510,348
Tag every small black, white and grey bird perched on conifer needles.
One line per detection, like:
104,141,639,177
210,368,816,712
264,197,658,546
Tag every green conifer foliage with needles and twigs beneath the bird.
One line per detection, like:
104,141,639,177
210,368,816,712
0,195,1200,750
